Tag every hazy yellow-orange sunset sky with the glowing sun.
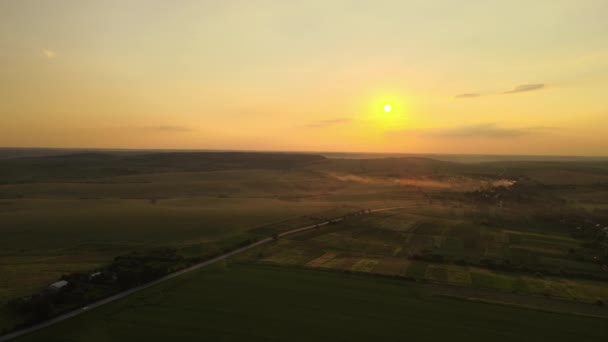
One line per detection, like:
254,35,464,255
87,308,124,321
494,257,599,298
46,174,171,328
0,0,608,155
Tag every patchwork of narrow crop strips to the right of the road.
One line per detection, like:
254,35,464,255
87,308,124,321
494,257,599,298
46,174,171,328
239,205,608,310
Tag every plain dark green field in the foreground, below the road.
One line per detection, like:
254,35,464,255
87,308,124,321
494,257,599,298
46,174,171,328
17,266,608,342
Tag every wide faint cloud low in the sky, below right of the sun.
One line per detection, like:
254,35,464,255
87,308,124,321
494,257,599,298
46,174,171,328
393,123,554,139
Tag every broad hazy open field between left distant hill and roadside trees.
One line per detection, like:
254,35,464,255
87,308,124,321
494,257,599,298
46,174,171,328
0,164,410,308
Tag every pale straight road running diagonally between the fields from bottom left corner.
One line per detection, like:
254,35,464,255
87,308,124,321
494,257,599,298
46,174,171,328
0,207,405,342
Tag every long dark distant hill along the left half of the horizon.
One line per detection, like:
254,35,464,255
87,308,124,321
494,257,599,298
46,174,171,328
0,152,326,184
